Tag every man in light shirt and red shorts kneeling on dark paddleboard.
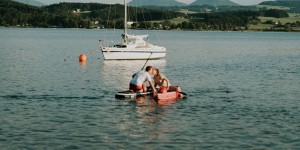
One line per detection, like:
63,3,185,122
129,66,156,93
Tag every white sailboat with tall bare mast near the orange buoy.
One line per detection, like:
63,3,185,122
100,0,166,60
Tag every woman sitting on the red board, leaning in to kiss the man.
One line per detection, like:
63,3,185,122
153,68,181,93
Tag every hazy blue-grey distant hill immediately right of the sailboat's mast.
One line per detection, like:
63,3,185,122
128,0,187,7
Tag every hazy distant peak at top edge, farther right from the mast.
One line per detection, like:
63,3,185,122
190,0,239,6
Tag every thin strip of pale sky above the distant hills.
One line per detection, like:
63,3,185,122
37,0,268,5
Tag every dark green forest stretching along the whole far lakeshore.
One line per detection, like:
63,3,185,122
0,0,300,31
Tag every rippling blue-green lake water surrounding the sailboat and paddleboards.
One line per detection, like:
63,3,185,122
0,28,300,150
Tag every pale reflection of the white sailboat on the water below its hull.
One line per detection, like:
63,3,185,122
100,59,166,91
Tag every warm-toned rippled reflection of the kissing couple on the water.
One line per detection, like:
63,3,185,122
114,96,177,146
